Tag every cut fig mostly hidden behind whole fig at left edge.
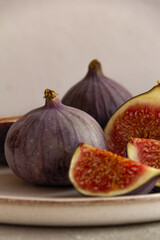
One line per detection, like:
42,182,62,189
0,116,20,164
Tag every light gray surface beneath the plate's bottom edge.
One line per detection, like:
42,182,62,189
0,222,160,240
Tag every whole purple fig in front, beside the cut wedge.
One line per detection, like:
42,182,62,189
5,89,106,186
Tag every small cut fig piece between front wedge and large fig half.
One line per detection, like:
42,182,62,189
127,138,160,187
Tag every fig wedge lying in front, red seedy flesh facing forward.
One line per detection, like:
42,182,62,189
69,143,160,197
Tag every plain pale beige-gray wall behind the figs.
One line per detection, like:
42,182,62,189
0,0,160,117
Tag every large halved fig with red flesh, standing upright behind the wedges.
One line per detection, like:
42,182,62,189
104,82,160,156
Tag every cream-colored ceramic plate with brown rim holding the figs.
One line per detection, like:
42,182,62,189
0,167,160,226
